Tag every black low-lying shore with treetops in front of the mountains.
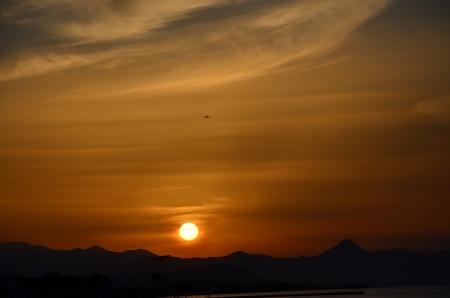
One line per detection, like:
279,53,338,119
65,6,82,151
0,272,370,298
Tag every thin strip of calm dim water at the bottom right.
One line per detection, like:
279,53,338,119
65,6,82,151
190,285,450,298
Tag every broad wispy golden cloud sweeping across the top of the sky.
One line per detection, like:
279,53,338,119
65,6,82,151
0,0,389,88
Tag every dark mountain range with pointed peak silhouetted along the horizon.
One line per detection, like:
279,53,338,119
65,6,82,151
0,239,450,285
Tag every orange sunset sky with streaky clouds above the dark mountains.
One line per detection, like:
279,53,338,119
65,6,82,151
0,0,450,257
